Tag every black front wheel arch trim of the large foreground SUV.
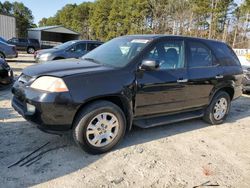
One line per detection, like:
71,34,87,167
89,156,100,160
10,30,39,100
71,95,133,131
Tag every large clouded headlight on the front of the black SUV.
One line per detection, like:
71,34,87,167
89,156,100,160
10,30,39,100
30,76,69,92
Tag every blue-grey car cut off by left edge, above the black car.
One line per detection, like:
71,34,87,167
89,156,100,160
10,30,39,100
0,41,18,59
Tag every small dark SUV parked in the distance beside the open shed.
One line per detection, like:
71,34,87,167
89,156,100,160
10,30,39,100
8,38,41,54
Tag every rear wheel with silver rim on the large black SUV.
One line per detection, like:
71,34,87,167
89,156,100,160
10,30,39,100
203,91,231,125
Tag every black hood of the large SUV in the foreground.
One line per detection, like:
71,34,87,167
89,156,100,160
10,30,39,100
23,59,113,77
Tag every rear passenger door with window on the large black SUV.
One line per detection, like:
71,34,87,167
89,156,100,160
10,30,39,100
186,39,224,108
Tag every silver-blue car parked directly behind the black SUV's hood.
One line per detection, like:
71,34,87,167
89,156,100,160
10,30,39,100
34,40,103,62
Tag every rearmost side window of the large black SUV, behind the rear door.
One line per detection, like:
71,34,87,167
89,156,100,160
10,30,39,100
212,42,240,66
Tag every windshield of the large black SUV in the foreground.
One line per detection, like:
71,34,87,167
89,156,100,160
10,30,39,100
82,38,150,67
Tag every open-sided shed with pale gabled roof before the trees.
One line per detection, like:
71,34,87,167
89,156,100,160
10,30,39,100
28,26,80,48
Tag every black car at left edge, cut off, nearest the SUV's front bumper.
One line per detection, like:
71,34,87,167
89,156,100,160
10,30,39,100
0,58,13,88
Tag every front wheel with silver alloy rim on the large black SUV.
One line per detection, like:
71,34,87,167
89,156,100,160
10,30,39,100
73,101,126,154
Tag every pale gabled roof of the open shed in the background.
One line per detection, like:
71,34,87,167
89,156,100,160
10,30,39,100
28,25,80,35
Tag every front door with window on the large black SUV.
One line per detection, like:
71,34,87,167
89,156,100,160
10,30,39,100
135,40,187,116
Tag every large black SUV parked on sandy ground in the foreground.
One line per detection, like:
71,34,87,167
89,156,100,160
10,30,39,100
12,35,243,154
